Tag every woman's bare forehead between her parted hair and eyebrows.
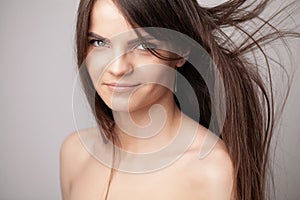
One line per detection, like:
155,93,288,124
89,0,132,38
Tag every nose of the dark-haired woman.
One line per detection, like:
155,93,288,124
108,53,133,77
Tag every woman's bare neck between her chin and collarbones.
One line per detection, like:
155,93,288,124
114,97,181,153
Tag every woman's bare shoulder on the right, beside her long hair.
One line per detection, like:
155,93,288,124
188,127,234,200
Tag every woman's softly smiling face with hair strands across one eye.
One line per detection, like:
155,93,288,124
86,0,183,111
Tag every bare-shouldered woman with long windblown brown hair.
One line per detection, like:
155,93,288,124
61,0,298,200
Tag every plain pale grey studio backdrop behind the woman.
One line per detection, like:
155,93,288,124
0,0,300,200
